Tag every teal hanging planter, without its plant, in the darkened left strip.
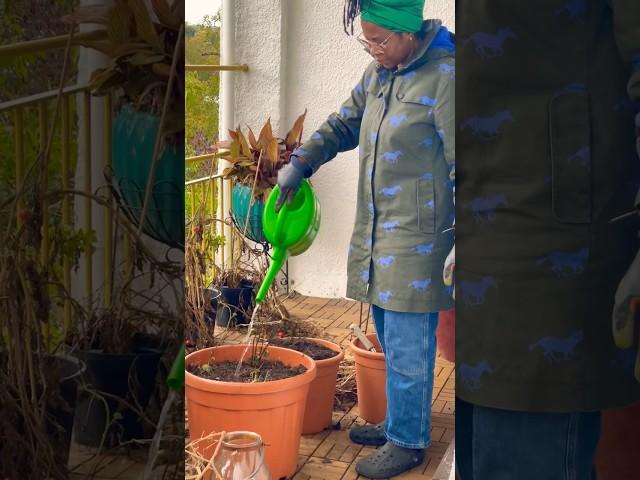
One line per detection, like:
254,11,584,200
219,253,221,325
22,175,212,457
111,105,184,249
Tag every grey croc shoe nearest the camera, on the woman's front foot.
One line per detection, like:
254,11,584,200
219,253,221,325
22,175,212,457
356,442,424,480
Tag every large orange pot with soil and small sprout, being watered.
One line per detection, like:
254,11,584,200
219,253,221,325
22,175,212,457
185,320,316,478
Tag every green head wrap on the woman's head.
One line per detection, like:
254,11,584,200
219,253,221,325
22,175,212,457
361,0,424,33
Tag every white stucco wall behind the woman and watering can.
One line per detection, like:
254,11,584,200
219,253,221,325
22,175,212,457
223,0,455,297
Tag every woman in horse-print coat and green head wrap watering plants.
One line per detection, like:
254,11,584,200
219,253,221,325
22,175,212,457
278,0,454,478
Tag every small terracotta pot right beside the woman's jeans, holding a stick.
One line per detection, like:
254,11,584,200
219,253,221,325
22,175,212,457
351,333,387,423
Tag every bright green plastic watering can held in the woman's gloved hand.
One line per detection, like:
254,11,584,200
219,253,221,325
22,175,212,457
256,180,320,304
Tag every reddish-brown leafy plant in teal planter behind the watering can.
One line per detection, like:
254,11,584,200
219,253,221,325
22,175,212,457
215,110,307,243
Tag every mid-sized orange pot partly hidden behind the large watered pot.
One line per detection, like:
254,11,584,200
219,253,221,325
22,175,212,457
302,338,344,435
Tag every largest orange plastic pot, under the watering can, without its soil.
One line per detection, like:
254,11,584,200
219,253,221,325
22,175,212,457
185,345,316,479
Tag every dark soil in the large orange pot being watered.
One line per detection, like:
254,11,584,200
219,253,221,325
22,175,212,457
187,360,307,383
